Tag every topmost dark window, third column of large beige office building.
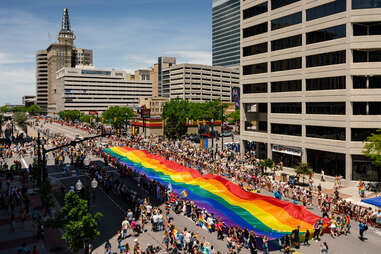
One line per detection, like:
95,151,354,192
306,0,344,21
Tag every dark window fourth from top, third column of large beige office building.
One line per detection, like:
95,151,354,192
306,76,346,91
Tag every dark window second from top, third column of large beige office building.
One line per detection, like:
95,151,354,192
306,24,346,44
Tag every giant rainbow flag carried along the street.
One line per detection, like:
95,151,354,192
105,147,320,239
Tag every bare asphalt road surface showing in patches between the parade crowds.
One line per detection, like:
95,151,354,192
16,124,381,254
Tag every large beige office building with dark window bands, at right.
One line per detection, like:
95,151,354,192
241,0,381,181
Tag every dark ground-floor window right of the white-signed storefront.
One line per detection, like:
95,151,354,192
307,149,345,178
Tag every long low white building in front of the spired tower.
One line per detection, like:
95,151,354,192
55,66,152,113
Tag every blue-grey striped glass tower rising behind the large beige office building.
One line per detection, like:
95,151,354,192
212,0,240,66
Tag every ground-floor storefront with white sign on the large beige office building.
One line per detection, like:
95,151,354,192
271,145,302,167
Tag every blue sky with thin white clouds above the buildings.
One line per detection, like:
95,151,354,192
0,0,212,105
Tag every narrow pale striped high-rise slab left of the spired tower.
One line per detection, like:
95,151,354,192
36,50,48,114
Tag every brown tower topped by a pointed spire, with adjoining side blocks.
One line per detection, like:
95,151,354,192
36,8,93,113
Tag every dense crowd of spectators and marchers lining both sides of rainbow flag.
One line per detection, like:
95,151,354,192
0,118,381,254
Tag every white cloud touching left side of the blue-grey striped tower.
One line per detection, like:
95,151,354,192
167,50,212,65
